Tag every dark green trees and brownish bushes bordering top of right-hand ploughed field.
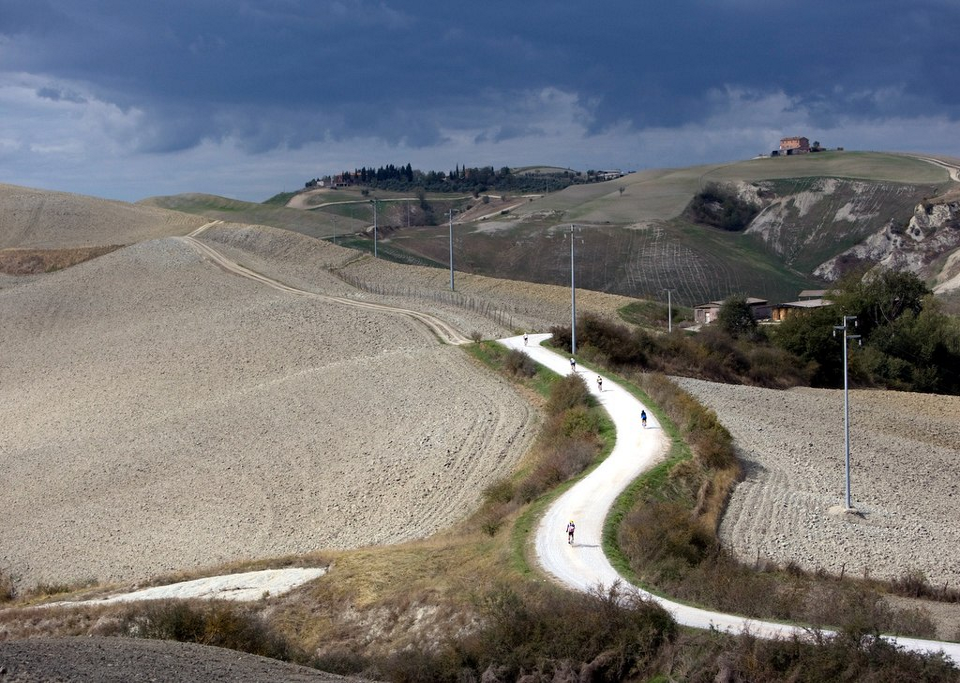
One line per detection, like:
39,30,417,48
604,270,960,395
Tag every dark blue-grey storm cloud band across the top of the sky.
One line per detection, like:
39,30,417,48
2,0,960,149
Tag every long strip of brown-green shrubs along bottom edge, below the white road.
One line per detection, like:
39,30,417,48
315,582,958,683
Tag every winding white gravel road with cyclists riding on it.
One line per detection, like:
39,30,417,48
500,334,960,664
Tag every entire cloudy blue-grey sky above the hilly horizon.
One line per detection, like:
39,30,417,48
0,0,960,201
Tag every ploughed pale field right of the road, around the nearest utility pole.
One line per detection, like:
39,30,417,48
678,379,960,588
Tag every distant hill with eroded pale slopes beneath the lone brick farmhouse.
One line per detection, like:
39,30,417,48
272,152,960,305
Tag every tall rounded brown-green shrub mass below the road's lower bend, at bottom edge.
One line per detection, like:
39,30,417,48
317,582,678,683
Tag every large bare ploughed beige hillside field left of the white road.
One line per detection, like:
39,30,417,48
0,234,535,585
